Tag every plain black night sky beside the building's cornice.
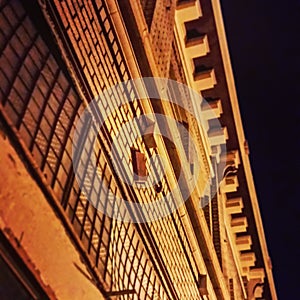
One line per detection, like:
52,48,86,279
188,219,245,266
221,0,300,300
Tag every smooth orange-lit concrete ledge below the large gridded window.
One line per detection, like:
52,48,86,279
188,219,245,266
0,135,104,300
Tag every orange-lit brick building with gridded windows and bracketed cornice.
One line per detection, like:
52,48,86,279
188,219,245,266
0,0,277,300
